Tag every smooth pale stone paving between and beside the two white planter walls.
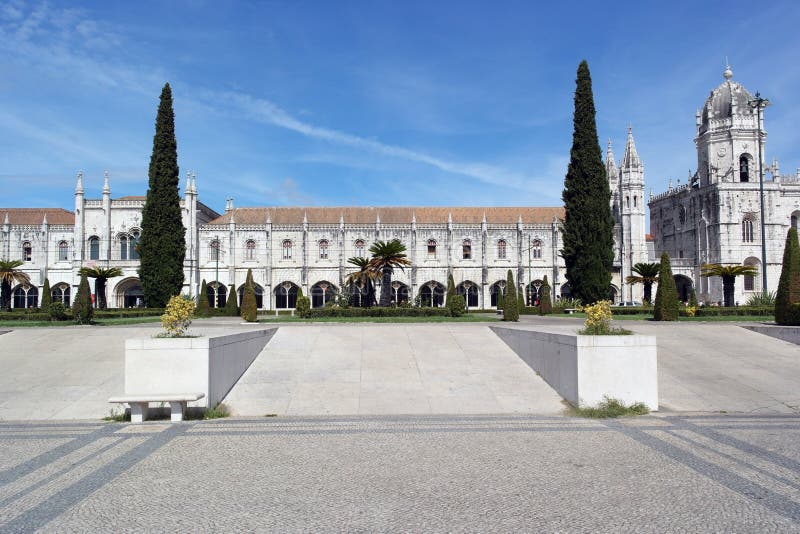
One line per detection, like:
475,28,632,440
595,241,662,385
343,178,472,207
0,316,800,421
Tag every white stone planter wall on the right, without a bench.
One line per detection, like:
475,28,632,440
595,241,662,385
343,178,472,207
490,326,658,410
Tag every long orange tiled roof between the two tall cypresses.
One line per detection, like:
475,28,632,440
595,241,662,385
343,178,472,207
209,206,564,224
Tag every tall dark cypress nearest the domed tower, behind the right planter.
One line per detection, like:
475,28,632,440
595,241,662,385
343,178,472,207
561,60,614,304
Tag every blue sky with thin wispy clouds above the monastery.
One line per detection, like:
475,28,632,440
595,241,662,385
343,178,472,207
0,0,800,218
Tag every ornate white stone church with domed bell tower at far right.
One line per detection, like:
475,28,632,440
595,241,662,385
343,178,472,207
649,68,800,304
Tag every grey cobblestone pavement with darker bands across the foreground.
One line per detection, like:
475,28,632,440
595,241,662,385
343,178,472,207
0,414,800,532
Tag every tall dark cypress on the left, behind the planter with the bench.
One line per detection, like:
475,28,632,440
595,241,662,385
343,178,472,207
139,83,186,308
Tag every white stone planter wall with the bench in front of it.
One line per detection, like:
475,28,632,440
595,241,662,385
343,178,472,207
125,328,277,407
